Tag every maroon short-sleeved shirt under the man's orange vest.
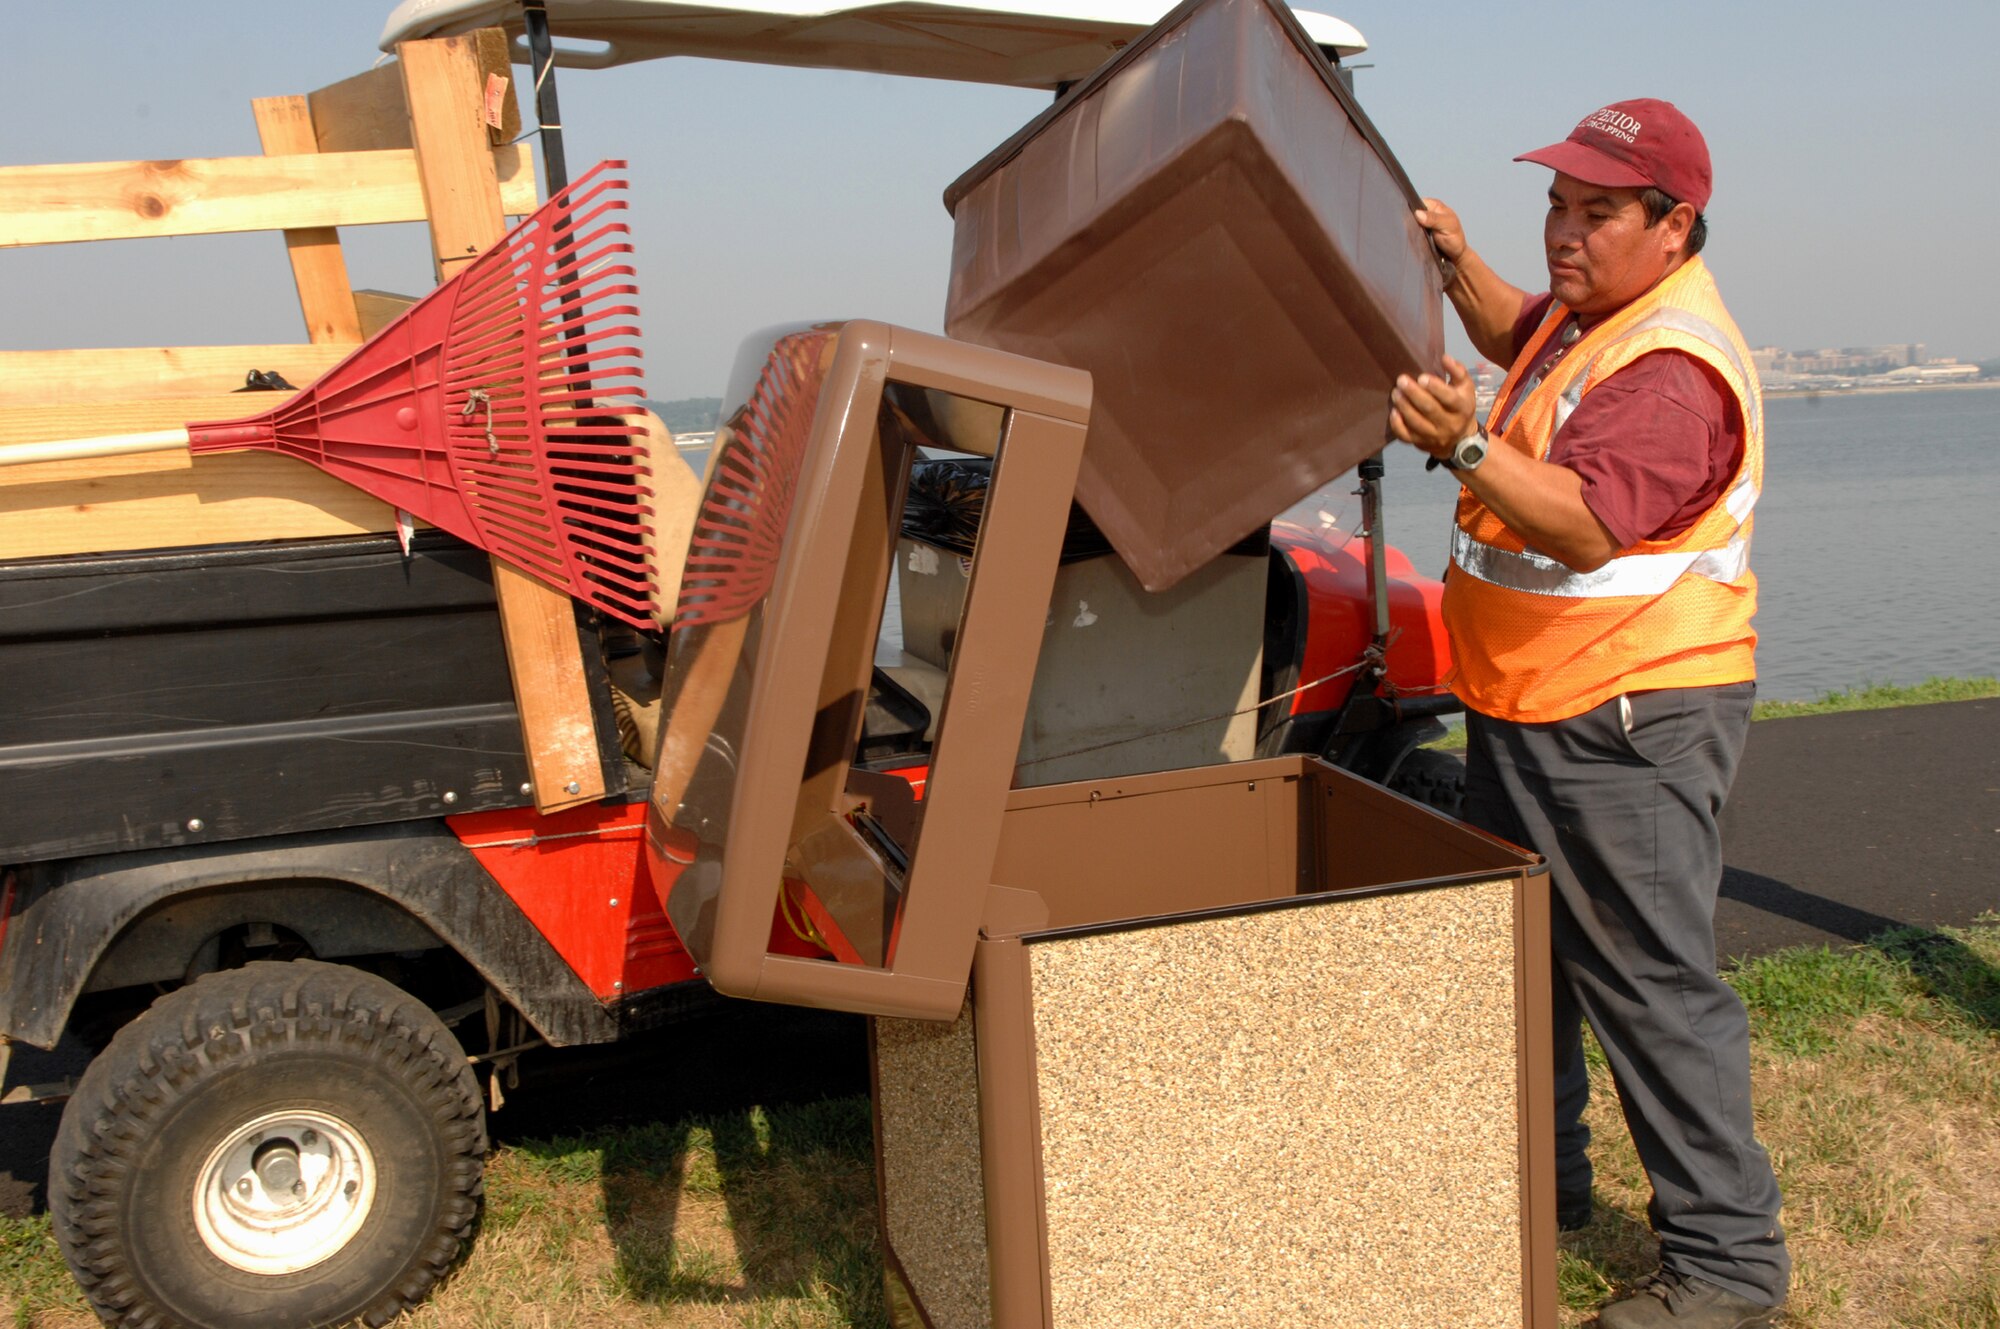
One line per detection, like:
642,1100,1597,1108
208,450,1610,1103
1500,292,1744,548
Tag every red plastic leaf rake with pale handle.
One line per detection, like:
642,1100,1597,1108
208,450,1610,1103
0,162,654,626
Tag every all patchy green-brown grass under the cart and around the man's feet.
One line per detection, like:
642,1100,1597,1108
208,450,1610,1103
0,932,2000,1329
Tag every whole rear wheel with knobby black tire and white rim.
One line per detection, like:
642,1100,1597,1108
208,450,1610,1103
48,961,486,1329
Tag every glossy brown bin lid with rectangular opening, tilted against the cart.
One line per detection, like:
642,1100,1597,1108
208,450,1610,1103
646,320,1090,1019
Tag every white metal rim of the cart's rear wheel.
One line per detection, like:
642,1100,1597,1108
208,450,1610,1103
194,1109,376,1273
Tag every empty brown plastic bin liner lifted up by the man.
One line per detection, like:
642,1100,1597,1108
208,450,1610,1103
944,0,1444,590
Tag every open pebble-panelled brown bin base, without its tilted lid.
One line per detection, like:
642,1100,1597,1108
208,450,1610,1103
872,757,1556,1329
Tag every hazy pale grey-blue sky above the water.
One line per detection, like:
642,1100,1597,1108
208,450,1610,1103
0,0,2000,398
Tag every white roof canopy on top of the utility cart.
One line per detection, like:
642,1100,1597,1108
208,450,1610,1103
380,0,1368,88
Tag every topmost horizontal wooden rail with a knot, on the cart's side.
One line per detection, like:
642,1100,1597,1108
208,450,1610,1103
0,144,536,248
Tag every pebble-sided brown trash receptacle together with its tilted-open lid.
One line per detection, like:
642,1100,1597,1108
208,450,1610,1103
646,322,1556,1329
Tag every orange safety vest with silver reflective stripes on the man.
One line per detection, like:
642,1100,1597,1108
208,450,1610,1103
1444,258,1764,723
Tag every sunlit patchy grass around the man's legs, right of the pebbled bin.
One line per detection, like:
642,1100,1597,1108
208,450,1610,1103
1558,915,2000,1329
